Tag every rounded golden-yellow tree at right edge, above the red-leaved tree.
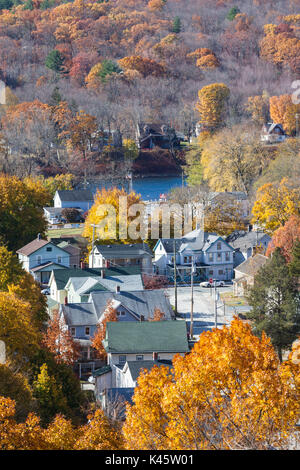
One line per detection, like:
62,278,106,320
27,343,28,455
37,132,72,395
252,178,300,234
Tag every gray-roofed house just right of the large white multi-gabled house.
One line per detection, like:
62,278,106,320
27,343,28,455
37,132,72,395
226,229,271,268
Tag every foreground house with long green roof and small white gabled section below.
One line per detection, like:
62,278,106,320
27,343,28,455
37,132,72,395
93,321,190,407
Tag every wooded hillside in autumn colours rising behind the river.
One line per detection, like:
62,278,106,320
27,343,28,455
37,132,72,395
0,0,300,180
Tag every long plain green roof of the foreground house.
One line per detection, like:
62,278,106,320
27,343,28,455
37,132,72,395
103,320,189,354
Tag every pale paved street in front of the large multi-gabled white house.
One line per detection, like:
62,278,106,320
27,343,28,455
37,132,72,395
165,285,248,337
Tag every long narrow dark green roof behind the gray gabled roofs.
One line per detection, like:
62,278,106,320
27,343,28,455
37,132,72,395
53,266,141,290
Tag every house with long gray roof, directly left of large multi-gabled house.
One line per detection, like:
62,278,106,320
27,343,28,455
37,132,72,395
89,243,153,274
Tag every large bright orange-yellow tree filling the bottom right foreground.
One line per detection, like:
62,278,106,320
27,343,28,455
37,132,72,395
123,319,300,450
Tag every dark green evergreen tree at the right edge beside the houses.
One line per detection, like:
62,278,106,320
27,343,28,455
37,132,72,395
247,248,300,361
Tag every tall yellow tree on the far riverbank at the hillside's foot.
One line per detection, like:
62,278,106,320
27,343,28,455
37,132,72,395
196,83,230,130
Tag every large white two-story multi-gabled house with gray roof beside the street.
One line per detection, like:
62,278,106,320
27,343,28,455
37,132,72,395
154,229,234,281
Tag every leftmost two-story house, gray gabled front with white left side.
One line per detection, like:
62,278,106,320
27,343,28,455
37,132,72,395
17,235,71,284
